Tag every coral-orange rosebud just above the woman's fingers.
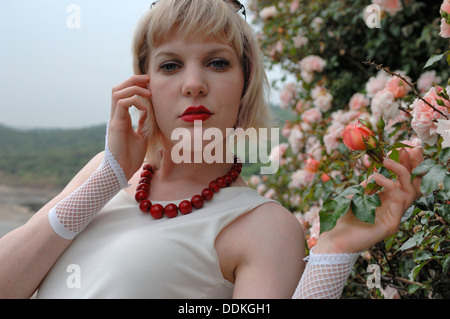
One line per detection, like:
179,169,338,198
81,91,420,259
342,122,377,151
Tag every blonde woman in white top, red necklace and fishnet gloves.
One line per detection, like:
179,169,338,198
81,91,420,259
0,0,421,298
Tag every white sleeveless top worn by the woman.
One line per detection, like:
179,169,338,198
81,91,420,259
37,187,278,298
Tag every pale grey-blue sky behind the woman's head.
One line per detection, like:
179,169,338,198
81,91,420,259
0,0,288,129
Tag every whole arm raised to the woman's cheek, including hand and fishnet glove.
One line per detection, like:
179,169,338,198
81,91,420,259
0,75,151,298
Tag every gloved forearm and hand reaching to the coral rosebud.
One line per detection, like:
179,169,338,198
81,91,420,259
293,149,423,299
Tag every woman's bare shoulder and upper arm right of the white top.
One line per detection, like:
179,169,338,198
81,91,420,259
217,202,305,298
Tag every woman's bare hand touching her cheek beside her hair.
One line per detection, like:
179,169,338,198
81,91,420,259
108,74,151,180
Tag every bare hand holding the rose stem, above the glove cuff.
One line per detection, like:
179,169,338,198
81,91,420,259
314,148,423,254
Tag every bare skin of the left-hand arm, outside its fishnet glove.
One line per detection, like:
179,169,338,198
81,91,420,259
0,153,103,299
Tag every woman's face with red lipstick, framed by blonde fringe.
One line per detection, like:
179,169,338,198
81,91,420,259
148,36,244,152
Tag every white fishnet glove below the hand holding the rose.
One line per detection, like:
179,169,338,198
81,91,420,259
292,248,360,299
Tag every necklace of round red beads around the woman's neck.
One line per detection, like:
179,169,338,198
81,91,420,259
135,156,242,219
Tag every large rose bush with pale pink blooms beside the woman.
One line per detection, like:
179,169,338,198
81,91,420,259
249,0,450,298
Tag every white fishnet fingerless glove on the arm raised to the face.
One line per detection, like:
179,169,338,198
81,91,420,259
48,123,128,240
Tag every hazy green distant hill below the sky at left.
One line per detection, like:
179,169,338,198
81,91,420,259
0,125,106,188
